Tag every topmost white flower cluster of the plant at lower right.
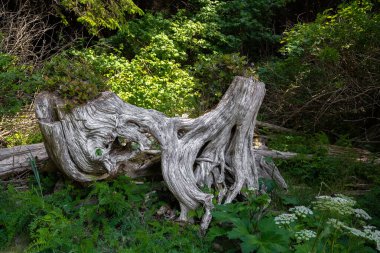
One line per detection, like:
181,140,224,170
313,194,356,216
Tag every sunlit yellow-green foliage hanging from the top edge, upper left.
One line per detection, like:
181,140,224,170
60,0,143,35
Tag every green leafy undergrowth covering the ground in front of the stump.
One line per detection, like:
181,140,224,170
0,136,380,252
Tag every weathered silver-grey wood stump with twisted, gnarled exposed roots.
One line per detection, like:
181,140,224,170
36,77,286,230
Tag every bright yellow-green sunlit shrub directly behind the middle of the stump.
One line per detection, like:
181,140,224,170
79,48,198,116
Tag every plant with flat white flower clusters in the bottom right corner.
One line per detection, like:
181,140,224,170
274,194,380,252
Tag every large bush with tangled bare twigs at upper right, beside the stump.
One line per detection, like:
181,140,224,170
258,0,380,136
